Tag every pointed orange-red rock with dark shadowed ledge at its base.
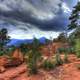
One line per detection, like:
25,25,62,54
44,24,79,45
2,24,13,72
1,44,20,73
5,48,24,67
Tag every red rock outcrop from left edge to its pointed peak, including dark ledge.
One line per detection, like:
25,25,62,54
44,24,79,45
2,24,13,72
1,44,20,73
0,49,23,73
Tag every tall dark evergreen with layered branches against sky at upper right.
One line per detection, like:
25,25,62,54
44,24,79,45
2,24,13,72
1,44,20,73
69,2,80,29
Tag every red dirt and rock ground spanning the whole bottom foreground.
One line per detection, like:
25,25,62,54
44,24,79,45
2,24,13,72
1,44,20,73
0,55,80,80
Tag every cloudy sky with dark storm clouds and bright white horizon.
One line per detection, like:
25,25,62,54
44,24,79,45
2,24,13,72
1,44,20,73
0,0,78,39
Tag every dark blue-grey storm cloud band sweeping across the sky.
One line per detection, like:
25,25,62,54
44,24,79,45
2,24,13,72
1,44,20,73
0,6,67,30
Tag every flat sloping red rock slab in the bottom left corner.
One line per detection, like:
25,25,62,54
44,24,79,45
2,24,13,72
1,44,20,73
0,64,27,80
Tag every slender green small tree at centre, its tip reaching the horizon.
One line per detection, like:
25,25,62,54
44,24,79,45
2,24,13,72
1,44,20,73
28,38,41,74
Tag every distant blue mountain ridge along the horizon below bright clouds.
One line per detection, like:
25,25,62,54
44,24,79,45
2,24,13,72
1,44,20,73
7,37,46,46
